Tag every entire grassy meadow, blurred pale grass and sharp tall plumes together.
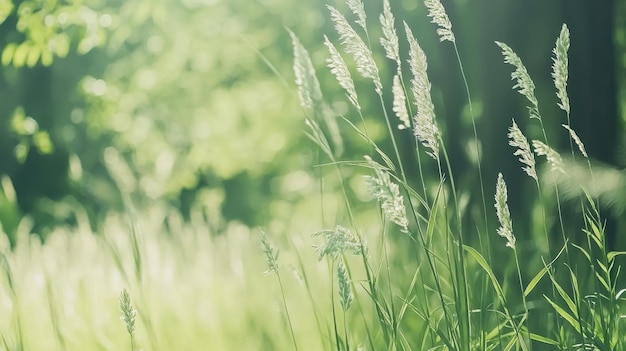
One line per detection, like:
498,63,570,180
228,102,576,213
0,0,626,351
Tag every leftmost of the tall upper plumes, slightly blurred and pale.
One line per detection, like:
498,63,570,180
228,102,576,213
287,29,322,110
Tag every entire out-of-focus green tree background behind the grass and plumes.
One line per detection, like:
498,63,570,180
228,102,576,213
0,0,626,248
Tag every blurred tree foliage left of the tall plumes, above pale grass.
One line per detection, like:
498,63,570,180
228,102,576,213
0,0,334,243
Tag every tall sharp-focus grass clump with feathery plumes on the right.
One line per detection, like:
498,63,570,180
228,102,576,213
264,0,626,350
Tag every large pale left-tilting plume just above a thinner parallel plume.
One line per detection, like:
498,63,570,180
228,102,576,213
327,5,383,95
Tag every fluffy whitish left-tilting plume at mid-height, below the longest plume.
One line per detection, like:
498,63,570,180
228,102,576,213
365,156,409,233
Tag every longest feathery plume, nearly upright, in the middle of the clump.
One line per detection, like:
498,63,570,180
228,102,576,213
404,22,440,161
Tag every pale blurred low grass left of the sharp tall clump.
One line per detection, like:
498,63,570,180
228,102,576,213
0,204,330,351
